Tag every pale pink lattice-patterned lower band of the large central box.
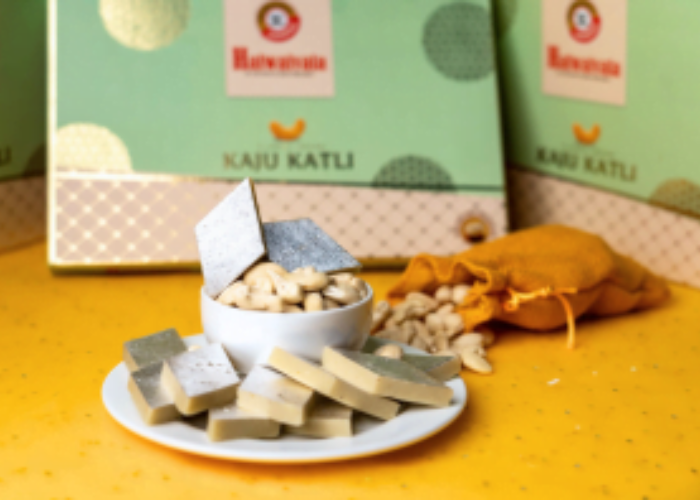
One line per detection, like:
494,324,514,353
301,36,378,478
51,171,506,266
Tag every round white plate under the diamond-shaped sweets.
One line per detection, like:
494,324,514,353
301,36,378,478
102,335,467,463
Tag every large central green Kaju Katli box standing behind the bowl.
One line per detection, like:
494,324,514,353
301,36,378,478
49,0,506,270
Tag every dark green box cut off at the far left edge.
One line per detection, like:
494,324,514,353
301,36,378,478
0,0,46,251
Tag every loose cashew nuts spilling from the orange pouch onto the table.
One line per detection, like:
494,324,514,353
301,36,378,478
372,285,495,373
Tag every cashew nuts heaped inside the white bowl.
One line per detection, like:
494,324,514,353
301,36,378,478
216,262,368,313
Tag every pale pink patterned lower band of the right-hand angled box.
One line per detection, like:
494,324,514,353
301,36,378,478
508,168,700,286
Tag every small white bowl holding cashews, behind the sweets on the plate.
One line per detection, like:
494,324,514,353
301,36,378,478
200,285,374,373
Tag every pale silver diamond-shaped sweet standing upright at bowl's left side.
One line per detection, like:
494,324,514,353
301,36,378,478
195,179,266,298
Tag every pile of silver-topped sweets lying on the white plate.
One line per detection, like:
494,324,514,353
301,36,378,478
124,329,459,441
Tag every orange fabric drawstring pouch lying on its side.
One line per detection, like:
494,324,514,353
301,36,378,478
389,226,669,348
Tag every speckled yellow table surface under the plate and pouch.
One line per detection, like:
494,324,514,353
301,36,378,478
0,245,700,500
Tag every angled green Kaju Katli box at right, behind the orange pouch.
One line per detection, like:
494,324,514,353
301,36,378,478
494,0,700,286
